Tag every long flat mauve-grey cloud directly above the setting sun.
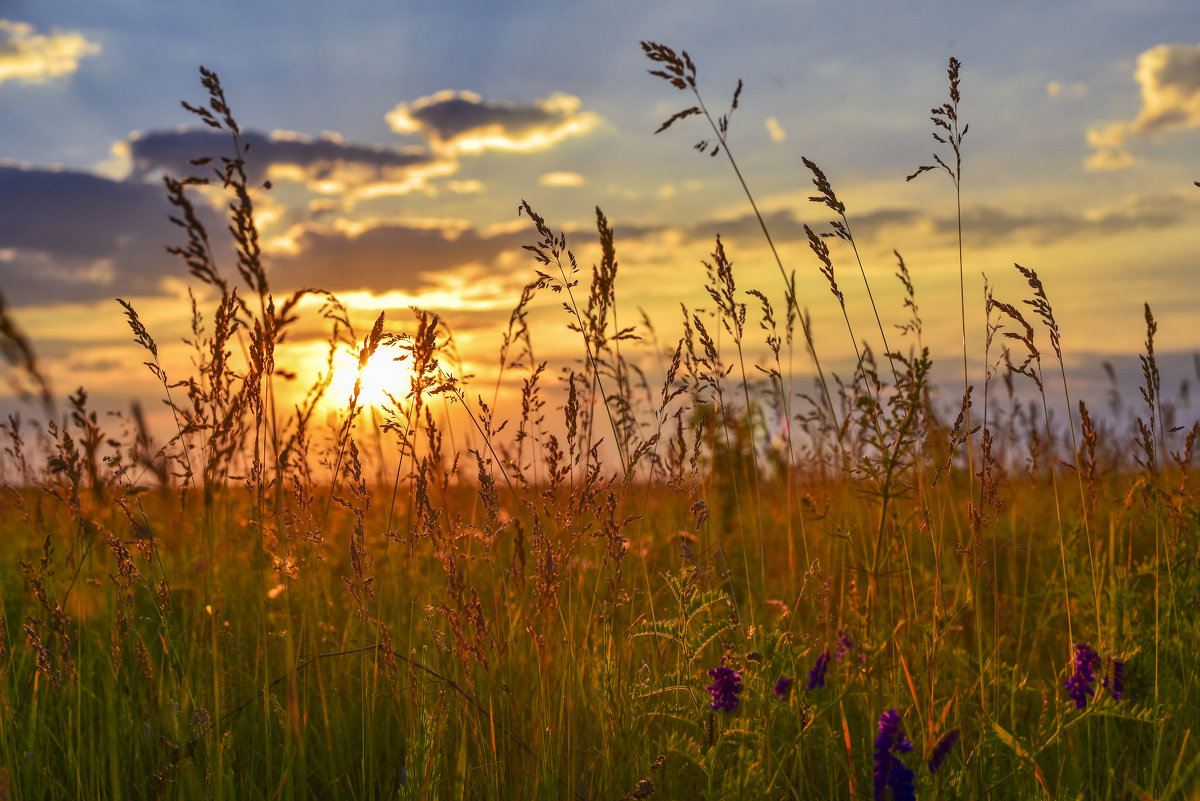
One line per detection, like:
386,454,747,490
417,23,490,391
270,224,530,293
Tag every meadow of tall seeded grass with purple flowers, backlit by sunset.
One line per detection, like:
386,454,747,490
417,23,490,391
0,42,1200,801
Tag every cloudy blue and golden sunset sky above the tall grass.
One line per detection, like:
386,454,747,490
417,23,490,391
0,0,1200,438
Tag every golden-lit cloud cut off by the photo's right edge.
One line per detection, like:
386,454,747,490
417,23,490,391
1085,44,1200,170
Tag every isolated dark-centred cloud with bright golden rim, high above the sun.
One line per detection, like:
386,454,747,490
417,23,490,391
385,90,600,155
